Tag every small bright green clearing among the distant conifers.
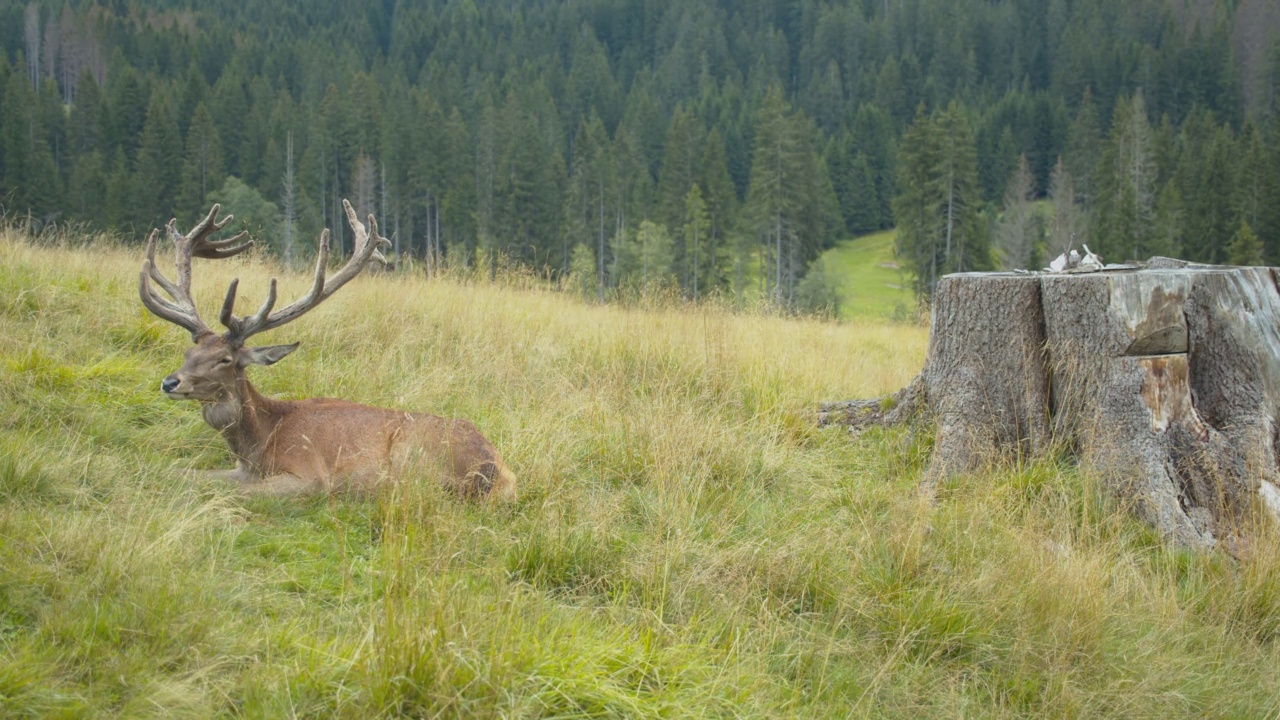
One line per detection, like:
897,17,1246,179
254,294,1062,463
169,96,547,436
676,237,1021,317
823,231,915,320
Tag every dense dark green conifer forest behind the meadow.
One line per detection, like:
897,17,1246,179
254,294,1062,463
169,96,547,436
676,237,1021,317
0,0,1280,305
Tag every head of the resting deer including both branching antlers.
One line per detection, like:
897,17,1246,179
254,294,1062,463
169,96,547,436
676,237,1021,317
138,200,390,401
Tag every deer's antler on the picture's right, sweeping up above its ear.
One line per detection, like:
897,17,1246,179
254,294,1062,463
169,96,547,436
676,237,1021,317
219,200,390,345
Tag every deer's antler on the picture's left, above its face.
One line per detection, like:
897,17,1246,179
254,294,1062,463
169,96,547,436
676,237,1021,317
138,204,253,340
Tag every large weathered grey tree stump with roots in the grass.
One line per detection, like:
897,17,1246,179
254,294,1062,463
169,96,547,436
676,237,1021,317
819,258,1280,547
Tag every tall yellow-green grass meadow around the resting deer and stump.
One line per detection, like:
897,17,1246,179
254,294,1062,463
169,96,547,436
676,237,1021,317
0,228,1280,719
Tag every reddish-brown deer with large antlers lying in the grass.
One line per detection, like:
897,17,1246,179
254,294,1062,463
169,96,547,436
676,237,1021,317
138,200,516,501
